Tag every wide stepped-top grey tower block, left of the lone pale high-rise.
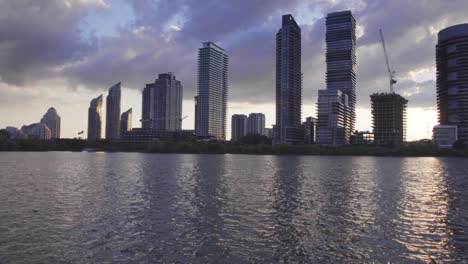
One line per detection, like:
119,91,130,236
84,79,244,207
141,72,183,131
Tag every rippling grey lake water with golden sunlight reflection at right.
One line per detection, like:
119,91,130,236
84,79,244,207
0,152,468,263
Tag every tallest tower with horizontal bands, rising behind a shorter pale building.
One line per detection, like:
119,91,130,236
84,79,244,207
317,11,356,144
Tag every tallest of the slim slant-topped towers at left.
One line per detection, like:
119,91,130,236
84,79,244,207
106,82,121,139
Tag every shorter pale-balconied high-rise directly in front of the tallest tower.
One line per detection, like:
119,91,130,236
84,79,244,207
316,89,348,146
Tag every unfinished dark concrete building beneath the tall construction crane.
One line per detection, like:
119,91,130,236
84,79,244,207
370,93,408,145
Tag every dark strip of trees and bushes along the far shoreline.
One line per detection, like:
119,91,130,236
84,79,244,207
0,137,468,157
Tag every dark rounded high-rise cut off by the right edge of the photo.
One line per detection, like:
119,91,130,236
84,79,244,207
436,24,468,143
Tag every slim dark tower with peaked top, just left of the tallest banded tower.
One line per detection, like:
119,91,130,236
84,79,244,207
273,15,303,144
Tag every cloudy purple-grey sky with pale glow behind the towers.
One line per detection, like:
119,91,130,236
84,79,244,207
0,0,468,140
